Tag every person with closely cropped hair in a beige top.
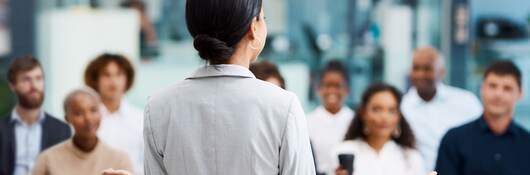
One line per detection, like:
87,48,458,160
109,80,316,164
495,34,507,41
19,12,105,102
32,88,132,175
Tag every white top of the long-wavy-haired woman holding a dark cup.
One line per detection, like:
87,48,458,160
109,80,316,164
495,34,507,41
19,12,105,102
328,139,427,175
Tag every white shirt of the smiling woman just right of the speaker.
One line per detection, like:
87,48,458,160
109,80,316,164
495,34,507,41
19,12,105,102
307,106,354,173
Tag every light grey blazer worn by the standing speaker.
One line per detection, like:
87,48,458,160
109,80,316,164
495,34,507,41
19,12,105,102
144,65,315,175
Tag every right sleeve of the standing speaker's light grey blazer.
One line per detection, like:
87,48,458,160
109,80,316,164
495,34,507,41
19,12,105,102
279,95,315,175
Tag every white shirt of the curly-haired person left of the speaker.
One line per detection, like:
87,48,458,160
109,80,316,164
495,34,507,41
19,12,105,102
98,101,144,174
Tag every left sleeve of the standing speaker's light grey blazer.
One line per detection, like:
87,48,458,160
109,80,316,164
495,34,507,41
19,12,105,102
144,104,167,175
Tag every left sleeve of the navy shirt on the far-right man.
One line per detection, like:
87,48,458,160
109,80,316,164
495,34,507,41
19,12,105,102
436,131,461,175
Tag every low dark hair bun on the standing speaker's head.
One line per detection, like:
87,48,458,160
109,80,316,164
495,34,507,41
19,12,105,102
193,35,234,63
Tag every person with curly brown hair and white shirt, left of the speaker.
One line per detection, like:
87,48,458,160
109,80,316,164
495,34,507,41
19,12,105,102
85,54,144,174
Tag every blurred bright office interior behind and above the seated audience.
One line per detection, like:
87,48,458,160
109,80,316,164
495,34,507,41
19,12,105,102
0,0,530,128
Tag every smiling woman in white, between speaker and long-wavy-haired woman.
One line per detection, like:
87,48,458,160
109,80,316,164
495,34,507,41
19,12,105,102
307,60,353,174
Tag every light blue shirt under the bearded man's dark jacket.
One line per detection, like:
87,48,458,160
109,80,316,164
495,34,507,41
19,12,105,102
11,110,44,175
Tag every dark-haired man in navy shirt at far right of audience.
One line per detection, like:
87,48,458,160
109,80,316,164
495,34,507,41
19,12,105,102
436,61,530,175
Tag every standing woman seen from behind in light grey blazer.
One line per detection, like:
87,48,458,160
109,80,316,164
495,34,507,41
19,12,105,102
140,0,315,175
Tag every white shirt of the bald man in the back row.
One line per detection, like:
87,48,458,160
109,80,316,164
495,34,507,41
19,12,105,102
401,83,482,170
